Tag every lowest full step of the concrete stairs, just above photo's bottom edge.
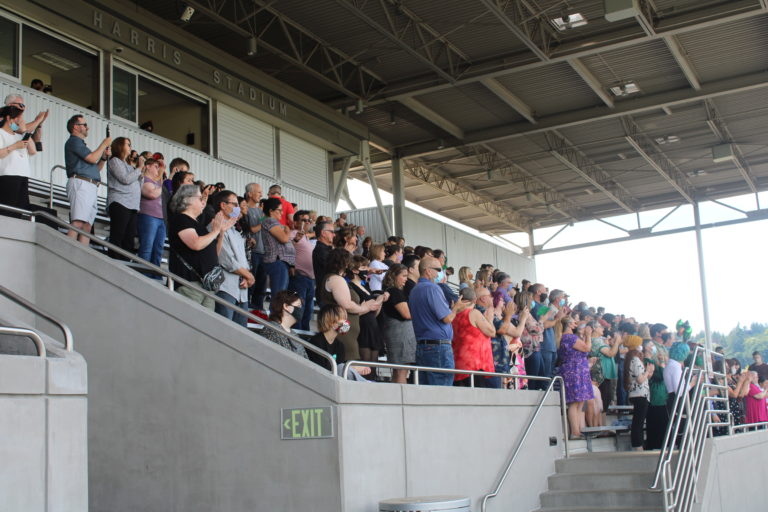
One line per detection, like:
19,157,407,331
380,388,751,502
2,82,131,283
541,489,664,510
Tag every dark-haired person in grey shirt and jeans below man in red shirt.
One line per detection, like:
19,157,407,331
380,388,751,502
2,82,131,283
261,197,296,300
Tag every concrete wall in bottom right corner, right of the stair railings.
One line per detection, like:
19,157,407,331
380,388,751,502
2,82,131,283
695,430,768,512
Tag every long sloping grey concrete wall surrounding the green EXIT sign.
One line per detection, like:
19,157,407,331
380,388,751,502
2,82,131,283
0,220,562,512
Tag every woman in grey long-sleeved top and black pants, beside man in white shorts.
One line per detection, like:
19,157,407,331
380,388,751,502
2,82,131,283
107,137,141,259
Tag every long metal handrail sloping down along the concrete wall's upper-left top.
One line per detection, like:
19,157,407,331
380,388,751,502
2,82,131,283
0,204,338,375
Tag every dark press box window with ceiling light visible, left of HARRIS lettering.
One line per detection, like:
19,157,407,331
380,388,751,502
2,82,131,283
22,26,99,112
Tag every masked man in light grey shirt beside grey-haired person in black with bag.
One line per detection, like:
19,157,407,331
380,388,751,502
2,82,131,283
210,190,256,327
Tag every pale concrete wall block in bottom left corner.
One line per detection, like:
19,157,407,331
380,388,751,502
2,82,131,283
0,318,88,512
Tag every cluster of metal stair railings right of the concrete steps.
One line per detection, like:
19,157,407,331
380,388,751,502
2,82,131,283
651,347,732,512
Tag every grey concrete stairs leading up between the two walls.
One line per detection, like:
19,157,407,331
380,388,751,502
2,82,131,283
536,452,664,512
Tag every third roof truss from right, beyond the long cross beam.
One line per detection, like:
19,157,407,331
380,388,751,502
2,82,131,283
545,130,640,213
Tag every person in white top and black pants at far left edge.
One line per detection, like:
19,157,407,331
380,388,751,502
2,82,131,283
0,106,37,210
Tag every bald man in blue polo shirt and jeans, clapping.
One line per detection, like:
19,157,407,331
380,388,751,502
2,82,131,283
408,256,472,386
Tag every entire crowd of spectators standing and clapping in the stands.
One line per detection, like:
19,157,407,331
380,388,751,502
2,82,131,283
0,95,768,449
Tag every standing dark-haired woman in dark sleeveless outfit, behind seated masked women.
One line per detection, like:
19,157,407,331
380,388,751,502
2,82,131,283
319,248,383,360
